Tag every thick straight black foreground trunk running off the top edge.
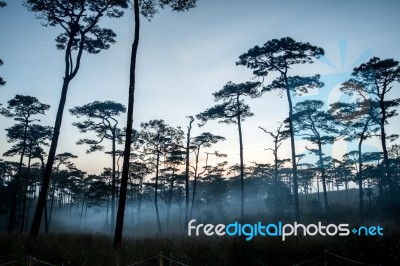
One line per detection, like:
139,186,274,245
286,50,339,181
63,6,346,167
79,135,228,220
114,0,140,248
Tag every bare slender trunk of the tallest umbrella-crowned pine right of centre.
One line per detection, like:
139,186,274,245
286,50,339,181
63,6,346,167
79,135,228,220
284,73,300,222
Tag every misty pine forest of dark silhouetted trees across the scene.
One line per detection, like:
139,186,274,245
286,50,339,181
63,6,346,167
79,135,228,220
0,0,400,265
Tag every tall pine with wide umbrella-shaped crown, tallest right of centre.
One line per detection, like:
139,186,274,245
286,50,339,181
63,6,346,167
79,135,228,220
236,37,324,221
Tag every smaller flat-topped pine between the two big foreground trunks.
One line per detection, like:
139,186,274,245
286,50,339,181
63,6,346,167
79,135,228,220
69,101,126,229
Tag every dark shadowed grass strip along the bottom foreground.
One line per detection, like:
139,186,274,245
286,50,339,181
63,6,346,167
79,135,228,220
0,229,400,265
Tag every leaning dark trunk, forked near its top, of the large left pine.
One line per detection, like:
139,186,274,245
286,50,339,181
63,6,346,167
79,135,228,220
30,33,85,239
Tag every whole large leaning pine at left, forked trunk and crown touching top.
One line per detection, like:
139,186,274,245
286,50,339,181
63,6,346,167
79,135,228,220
25,0,128,238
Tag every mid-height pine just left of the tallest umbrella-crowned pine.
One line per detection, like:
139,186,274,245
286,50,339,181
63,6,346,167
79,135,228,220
196,82,260,223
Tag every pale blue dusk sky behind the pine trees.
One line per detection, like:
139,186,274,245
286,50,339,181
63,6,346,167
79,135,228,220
0,0,400,174
